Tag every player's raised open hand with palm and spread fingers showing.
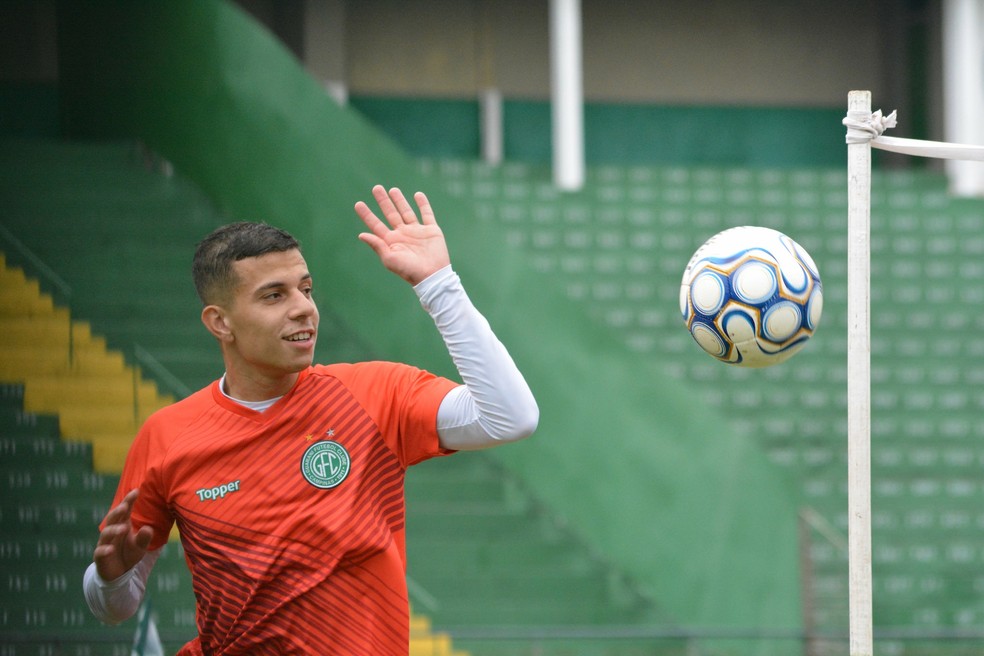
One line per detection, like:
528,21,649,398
355,185,451,285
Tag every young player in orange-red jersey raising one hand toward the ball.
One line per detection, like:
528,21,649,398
84,186,539,656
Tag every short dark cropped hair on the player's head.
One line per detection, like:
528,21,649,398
191,221,301,305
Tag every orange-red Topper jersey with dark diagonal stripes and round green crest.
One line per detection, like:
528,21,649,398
105,362,456,656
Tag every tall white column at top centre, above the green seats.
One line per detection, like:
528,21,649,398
550,0,584,191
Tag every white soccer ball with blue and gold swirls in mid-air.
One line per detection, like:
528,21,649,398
680,226,823,367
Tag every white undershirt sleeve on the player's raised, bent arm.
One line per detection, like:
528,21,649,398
414,265,539,450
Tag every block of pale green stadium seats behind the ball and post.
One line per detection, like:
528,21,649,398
421,159,984,653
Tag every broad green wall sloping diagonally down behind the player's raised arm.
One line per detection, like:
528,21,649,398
53,0,800,654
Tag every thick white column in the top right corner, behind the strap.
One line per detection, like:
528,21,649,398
943,0,984,196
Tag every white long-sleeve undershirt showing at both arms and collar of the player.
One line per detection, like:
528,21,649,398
83,265,540,624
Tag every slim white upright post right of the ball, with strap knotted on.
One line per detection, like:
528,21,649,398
847,91,873,656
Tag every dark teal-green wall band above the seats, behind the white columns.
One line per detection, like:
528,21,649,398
351,96,844,167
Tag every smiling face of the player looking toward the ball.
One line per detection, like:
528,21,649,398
224,249,318,383
